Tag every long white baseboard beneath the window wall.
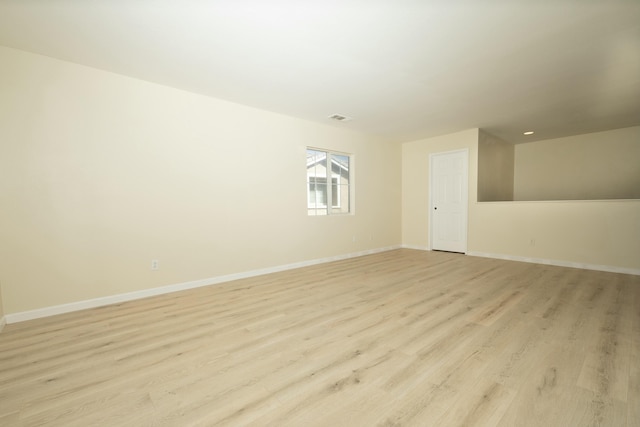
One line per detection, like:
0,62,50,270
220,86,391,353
5,245,401,330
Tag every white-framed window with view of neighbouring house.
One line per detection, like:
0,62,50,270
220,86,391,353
307,148,351,215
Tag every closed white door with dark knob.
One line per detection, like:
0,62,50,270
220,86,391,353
429,149,469,253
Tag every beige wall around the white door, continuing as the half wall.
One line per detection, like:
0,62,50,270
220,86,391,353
402,129,640,271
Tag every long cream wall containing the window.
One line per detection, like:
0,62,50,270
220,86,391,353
0,48,401,314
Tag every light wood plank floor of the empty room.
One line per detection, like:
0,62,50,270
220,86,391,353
0,249,640,427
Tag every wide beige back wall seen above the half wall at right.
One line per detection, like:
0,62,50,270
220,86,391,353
514,126,640,200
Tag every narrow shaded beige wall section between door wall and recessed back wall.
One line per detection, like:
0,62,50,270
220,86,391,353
478,129,514,202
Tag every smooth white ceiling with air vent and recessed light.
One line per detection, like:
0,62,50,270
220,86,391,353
0,0,640,143
